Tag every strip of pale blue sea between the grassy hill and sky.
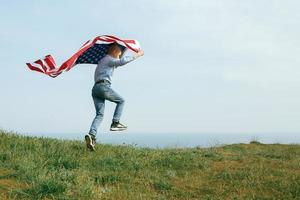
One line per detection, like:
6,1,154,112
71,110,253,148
25,131,300,148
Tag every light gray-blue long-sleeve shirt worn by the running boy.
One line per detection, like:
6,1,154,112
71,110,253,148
94,55,135,83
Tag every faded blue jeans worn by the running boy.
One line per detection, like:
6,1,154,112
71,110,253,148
89,83,125,136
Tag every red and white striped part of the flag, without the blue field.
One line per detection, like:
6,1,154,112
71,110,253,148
26,35,141,78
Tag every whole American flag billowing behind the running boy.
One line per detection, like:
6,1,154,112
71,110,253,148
26,35,141,78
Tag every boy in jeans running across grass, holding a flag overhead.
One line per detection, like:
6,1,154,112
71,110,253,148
85,43,144,151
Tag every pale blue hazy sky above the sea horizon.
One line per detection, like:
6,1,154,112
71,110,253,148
0,0,300,135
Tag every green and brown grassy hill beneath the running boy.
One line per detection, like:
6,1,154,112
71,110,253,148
0,131,300,200
